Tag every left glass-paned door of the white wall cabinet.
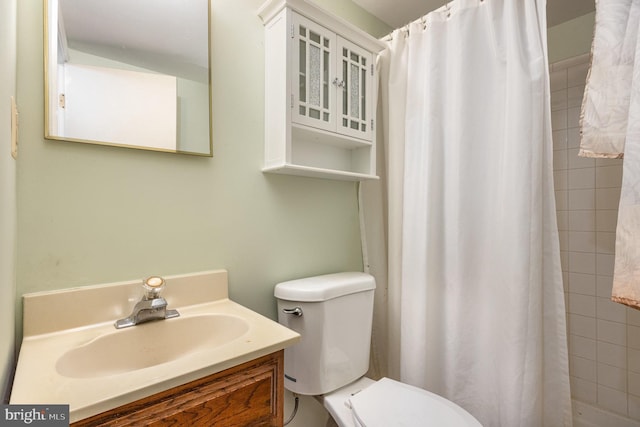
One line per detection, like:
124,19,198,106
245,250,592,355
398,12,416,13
292,14,336,130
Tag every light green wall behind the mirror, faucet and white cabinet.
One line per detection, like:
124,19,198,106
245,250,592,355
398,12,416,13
17,0,388,338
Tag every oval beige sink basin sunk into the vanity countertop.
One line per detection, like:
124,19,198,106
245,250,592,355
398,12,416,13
56,314,249,378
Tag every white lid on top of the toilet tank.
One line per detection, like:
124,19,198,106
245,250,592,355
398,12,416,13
274,271,376,302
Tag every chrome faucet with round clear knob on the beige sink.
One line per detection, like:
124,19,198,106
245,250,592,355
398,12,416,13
115,276,180,329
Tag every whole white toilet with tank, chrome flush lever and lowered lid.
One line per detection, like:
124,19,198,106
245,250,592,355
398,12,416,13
274,272,481,427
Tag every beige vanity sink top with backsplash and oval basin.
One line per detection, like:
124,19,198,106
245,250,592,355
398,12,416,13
10,270,300,424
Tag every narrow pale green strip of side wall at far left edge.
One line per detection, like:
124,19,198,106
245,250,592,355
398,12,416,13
0,0,18,403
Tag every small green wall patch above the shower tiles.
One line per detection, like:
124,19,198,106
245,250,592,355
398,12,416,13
547,12,596,64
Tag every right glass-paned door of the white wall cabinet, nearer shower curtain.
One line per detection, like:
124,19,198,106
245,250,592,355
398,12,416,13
337,37,374,140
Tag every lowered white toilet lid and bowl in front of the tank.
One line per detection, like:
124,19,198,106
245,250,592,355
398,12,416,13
324,378,482,427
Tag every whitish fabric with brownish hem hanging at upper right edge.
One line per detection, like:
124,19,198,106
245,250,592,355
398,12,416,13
580,0,640,309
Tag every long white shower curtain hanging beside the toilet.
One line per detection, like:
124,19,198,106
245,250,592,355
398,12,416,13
361,0,571,427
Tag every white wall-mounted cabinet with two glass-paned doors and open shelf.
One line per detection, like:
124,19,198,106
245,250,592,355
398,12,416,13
258,0,384,180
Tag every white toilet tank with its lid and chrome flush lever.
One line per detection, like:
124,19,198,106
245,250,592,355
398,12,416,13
274,272,376,395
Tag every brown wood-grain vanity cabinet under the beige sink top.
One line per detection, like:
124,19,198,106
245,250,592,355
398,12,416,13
71,350,284,427
